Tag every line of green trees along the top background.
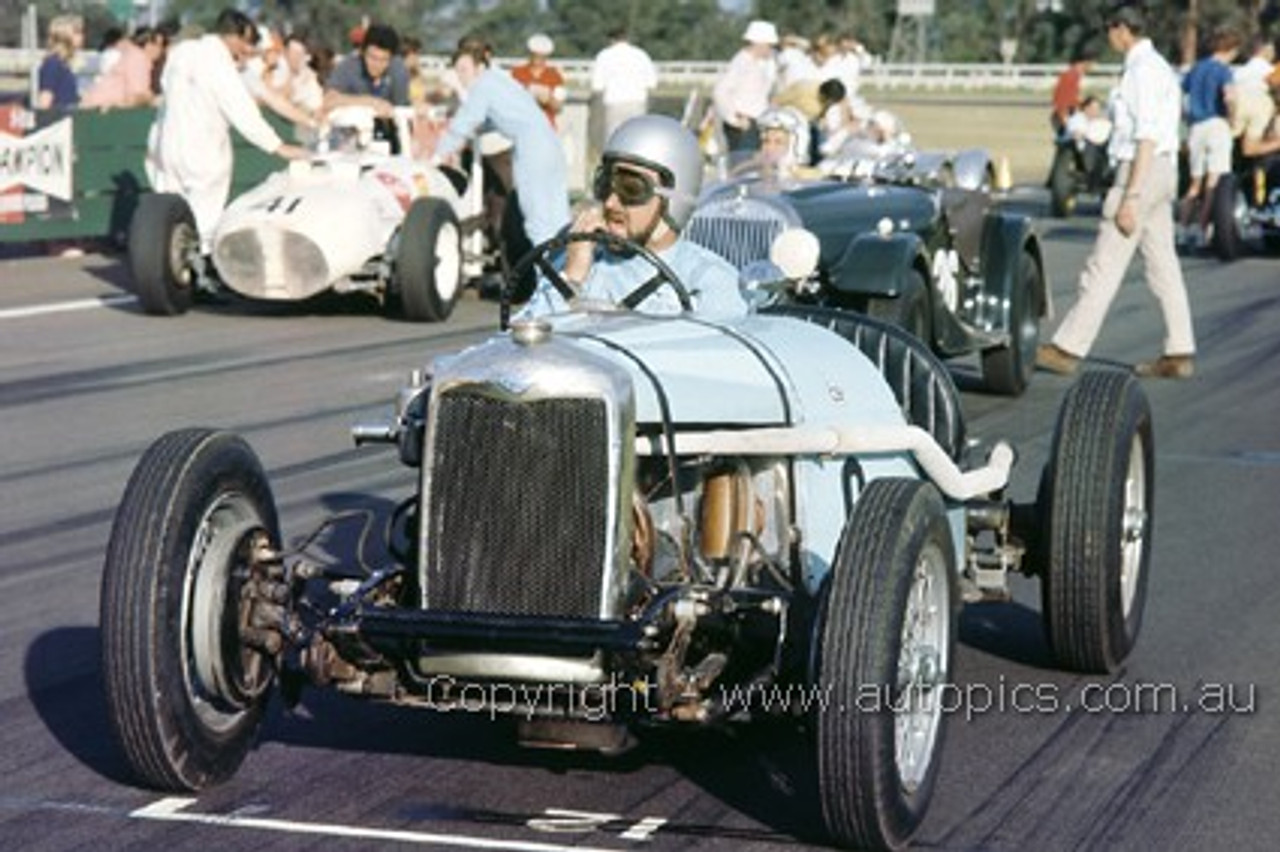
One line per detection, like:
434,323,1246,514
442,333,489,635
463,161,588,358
0,0,1280,63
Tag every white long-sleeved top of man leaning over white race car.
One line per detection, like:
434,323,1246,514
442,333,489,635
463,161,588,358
150,35,280,183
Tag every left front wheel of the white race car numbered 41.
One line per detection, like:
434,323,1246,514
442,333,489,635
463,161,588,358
129,193,200,316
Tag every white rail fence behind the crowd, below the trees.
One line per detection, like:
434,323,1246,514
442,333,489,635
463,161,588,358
0,47,1120,95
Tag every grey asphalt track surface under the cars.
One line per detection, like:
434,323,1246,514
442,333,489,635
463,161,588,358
0,195,1280,851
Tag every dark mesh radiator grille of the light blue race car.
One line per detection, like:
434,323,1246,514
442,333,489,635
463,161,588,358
424,391,611,618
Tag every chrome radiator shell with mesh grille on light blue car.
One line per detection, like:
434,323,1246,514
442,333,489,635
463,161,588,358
419,338,635,619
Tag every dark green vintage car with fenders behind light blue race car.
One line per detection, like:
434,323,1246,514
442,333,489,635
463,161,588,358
689,156,1050,395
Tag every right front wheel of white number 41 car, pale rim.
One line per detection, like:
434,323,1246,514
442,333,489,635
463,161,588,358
396,198,462,322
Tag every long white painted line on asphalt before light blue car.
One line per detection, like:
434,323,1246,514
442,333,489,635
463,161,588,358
129,796,621,852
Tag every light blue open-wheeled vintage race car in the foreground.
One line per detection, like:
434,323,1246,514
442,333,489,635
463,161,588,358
101,235,1153,848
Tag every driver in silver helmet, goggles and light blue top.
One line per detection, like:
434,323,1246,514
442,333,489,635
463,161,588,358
525,115,746,317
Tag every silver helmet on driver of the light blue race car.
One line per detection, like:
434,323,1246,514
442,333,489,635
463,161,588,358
600,115,703,230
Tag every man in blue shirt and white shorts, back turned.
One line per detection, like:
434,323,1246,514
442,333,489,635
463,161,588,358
1180,28,1240,239
